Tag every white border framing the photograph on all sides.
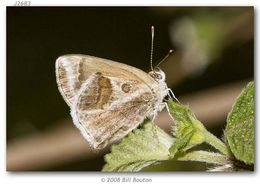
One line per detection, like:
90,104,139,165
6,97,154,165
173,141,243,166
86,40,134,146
0,0,259,186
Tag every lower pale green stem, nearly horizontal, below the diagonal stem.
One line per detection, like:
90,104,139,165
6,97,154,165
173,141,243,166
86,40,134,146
176,151,229,165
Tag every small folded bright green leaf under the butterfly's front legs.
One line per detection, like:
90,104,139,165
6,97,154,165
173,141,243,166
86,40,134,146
168,100,206,158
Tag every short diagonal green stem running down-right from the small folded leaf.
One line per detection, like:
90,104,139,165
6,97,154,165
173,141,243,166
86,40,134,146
204,130,231,157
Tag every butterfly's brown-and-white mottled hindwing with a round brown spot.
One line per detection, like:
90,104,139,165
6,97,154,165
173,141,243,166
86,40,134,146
71,73,157,148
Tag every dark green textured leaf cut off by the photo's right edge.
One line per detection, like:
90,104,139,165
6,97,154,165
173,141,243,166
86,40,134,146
225,82,254,164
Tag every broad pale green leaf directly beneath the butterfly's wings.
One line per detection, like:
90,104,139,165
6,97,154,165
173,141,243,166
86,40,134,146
102,121,173,172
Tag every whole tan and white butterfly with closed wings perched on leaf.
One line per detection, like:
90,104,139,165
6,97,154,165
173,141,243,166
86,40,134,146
56,26,172,149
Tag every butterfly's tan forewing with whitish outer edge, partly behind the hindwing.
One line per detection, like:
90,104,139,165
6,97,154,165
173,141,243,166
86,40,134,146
56,54,155,106
